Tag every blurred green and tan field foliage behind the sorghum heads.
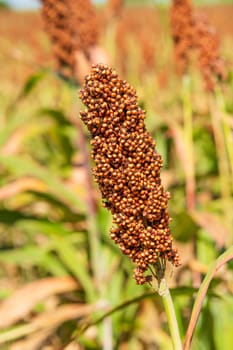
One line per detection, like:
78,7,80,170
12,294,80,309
0,1,233,350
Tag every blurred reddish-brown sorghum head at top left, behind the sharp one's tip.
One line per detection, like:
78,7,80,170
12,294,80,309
42,0,99,77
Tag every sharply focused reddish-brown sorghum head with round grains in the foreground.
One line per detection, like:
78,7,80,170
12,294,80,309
80,64,180,284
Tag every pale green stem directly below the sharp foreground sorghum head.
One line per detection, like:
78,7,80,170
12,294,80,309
158,278,182,350
